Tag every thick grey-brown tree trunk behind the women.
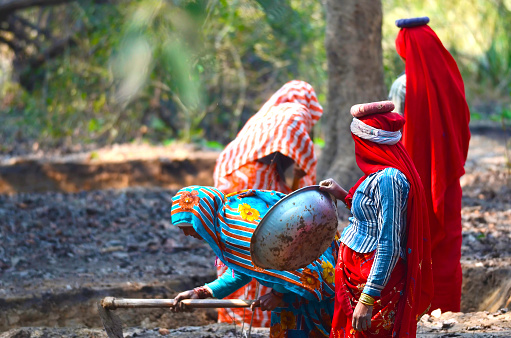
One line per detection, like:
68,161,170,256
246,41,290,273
318,0,386,188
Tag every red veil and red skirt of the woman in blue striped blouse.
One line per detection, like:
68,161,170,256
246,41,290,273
330,113,433,337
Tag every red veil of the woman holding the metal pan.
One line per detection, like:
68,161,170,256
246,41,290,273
346,113,433,337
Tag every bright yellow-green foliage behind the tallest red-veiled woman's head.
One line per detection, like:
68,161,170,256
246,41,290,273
383,0,511,118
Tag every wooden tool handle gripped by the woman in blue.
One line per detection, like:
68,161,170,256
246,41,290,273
101,297,254,310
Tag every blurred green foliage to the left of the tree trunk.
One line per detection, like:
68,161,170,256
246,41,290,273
0,0,326,148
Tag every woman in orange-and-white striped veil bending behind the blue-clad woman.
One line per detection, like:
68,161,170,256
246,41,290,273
214,80,323,326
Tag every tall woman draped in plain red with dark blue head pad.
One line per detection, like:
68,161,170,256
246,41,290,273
396,17,470,312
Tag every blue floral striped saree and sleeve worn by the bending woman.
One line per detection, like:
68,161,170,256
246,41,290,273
171,186,339,337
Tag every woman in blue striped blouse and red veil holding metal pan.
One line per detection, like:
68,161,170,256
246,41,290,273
320,101,433,338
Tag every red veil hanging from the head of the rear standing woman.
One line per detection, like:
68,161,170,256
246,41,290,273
396,25,470,247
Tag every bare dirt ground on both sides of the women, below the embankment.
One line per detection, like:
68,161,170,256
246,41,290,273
0,125,511,338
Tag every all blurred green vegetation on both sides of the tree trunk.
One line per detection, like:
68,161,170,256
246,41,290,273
0,0,511,154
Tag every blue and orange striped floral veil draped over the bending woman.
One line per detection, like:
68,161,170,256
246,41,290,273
172,186,338,301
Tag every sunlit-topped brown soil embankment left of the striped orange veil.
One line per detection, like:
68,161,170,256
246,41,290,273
0,144,218,194
